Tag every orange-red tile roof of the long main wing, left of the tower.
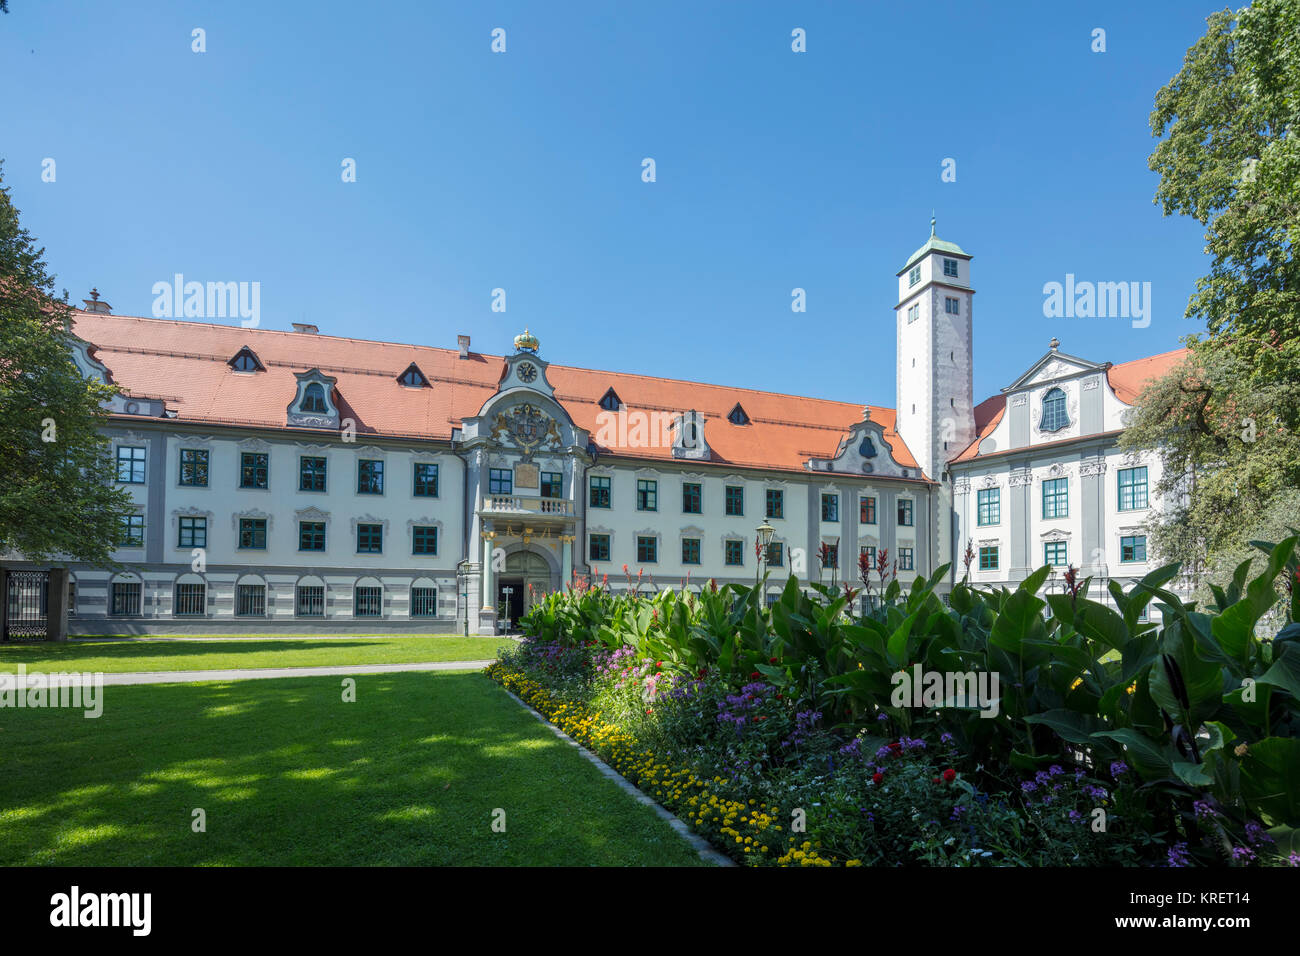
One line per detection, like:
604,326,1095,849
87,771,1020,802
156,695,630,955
74,312,918,472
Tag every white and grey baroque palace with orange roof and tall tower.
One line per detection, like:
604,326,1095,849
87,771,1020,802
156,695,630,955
50,222,1182,633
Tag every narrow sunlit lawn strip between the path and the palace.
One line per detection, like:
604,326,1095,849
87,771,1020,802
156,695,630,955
0,636,511,674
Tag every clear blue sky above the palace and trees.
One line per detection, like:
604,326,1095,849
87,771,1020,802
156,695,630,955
0,0,1222,407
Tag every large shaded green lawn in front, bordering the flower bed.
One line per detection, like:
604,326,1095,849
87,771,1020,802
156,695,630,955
0,672,703,866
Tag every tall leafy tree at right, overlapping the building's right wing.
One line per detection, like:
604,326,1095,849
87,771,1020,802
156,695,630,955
1121,0,1300,590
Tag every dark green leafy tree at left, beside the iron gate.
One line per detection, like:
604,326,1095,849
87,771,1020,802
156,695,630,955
0,164,134,566
